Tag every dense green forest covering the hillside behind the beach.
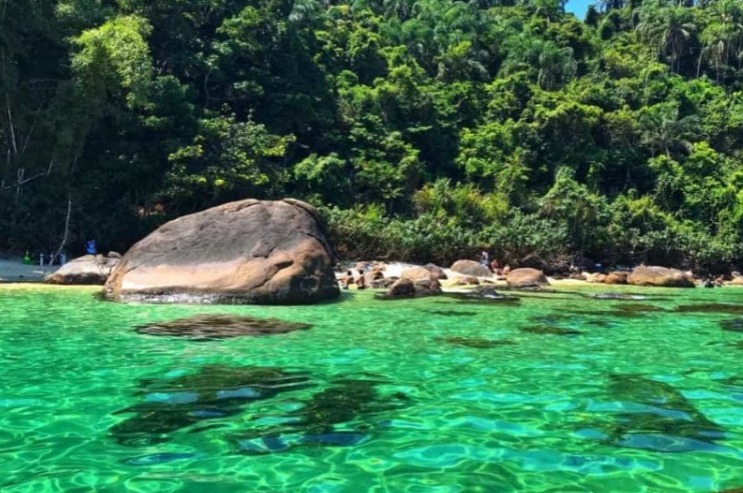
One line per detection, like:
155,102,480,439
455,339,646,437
0,0,743,269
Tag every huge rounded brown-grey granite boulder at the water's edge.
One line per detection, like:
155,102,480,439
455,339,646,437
105,199,340,304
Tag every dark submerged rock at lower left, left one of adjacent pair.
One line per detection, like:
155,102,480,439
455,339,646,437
109,365,312,446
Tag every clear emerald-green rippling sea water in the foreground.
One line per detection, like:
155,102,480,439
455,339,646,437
0,286,743,493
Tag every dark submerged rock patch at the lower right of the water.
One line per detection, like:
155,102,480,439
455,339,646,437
607,375,725,452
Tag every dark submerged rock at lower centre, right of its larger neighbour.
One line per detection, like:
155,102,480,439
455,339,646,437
236,379,408,455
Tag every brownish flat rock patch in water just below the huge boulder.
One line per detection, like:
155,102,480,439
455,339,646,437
136,315,312,341
